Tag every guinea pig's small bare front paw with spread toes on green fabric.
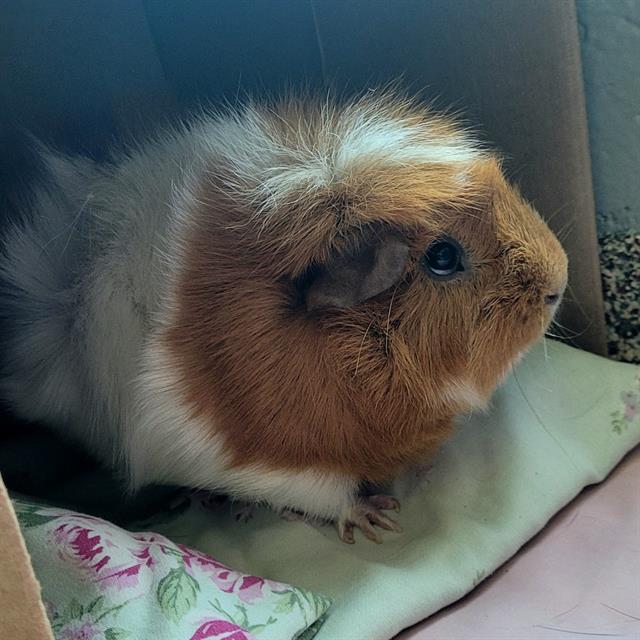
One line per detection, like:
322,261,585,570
336,494,402,544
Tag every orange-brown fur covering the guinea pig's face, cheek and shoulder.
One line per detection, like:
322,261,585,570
164,94,566,481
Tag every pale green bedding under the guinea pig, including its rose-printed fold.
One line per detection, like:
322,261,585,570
15,341,640,640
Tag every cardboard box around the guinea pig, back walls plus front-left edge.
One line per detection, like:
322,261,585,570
0,0,605,640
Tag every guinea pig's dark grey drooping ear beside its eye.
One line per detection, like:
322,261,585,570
306,236,409,311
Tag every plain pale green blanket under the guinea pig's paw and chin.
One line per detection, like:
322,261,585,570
148,341,640,640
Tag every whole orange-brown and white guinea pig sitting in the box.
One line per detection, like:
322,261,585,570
0,92,567,542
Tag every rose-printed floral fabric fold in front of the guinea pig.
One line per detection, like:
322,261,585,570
14,500,330,640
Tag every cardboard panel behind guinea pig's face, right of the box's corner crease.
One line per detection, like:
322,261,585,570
312,0,605,353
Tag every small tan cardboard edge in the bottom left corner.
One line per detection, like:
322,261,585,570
0,476,53,640
